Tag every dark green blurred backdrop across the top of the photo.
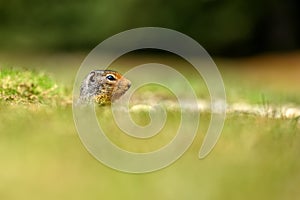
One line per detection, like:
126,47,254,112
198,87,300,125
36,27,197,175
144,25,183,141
0,0,300,56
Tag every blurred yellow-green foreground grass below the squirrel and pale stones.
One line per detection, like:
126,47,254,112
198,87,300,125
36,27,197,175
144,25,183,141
0,107,300,200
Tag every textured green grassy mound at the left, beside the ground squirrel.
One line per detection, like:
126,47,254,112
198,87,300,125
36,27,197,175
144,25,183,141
0,68,67,105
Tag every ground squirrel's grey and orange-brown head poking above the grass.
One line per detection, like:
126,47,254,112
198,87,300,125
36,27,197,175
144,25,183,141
79,70,131,105
